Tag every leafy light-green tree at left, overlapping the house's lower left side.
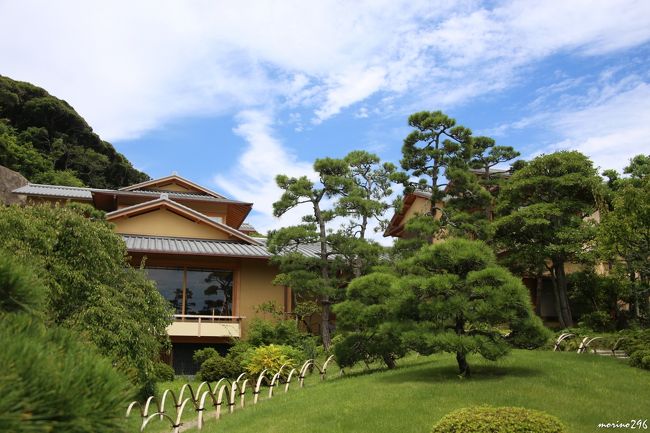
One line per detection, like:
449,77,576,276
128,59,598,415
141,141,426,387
0,206,171,392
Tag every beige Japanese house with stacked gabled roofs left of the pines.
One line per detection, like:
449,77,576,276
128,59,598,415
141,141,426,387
13,174,317,373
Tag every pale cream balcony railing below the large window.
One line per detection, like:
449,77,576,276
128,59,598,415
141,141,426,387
167,314,245,338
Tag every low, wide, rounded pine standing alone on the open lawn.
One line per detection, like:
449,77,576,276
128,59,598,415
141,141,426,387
396,239,550,376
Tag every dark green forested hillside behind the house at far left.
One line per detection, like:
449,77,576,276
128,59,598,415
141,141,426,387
0,76,148,188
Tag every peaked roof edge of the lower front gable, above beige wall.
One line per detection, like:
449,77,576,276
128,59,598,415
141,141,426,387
106,197,262,245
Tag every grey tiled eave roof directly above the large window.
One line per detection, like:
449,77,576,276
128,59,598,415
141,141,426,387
122,235,319,258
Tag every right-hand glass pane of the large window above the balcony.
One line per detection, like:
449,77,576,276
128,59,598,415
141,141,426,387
185,270,233,316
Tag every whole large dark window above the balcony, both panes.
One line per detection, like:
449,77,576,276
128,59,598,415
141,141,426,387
147,268,233,316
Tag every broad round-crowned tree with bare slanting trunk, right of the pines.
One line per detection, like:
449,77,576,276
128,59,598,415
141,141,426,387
495,151,601,327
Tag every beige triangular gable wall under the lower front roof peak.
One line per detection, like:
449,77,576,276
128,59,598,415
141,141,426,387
111,209,230,240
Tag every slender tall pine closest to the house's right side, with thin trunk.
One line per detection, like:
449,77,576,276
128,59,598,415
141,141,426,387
269,158,350,348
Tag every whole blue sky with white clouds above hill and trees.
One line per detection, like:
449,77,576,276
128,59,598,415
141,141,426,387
0,0,650,239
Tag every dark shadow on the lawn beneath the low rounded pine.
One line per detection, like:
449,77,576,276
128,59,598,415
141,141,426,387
378,365,544,383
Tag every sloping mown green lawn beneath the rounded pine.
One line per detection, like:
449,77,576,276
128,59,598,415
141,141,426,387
182,350,650,433
